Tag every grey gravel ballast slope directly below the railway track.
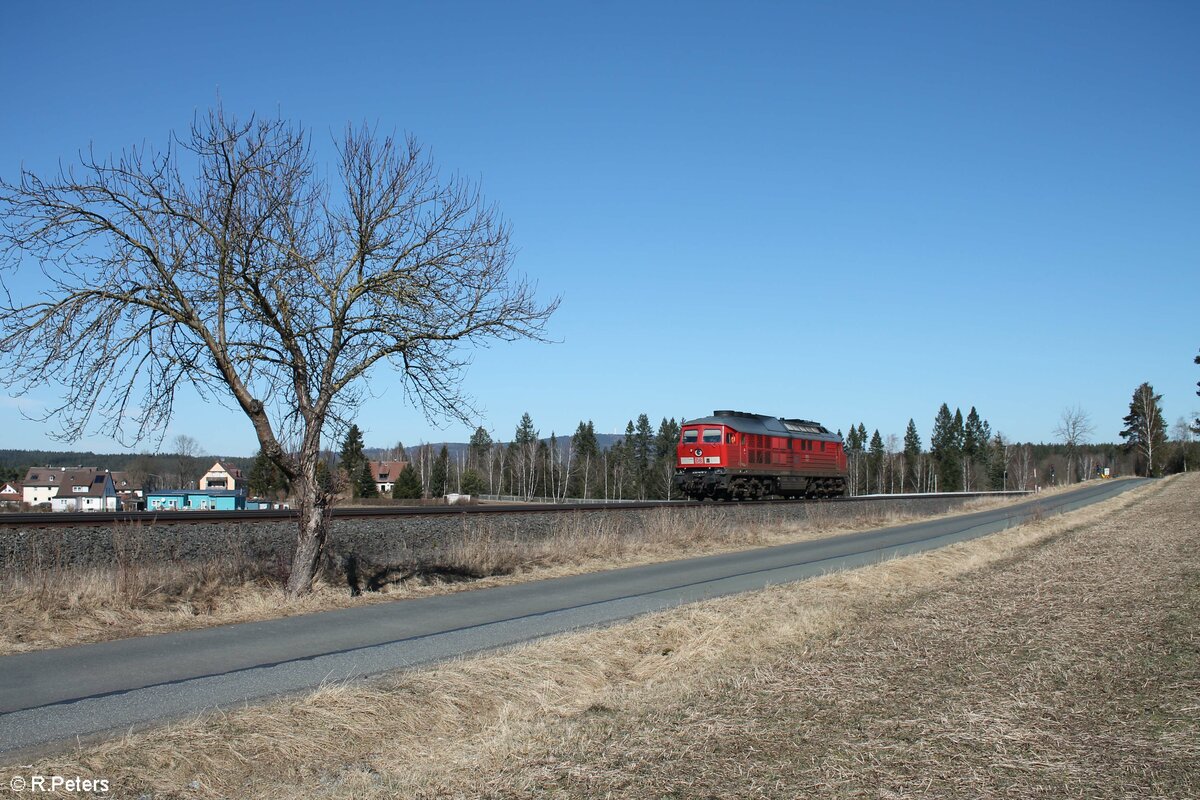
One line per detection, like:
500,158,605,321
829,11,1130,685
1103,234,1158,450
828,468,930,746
0,495,974,576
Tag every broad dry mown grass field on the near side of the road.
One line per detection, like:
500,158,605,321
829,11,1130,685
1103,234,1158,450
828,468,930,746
18,475,1200,800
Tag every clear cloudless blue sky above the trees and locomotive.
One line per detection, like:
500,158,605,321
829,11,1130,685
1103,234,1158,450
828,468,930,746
0,0,1200,455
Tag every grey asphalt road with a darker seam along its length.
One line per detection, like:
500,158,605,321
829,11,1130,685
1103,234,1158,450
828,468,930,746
0,480,1144,762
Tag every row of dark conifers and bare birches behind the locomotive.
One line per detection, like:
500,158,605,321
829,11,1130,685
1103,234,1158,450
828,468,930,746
248,371,1200,500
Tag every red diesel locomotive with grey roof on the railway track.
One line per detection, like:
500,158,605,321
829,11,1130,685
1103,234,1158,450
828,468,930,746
674,410,846,500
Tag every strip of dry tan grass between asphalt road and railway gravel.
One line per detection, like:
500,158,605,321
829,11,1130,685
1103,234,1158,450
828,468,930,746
0,499,1013,655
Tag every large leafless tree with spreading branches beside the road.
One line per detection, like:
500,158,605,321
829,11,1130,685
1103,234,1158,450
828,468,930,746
0,108,557,596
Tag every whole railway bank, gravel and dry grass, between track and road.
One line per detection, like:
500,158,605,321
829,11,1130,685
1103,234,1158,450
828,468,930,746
0,498,1027,655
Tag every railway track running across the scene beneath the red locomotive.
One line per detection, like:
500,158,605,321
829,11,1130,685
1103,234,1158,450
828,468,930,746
0,492,1031,528
